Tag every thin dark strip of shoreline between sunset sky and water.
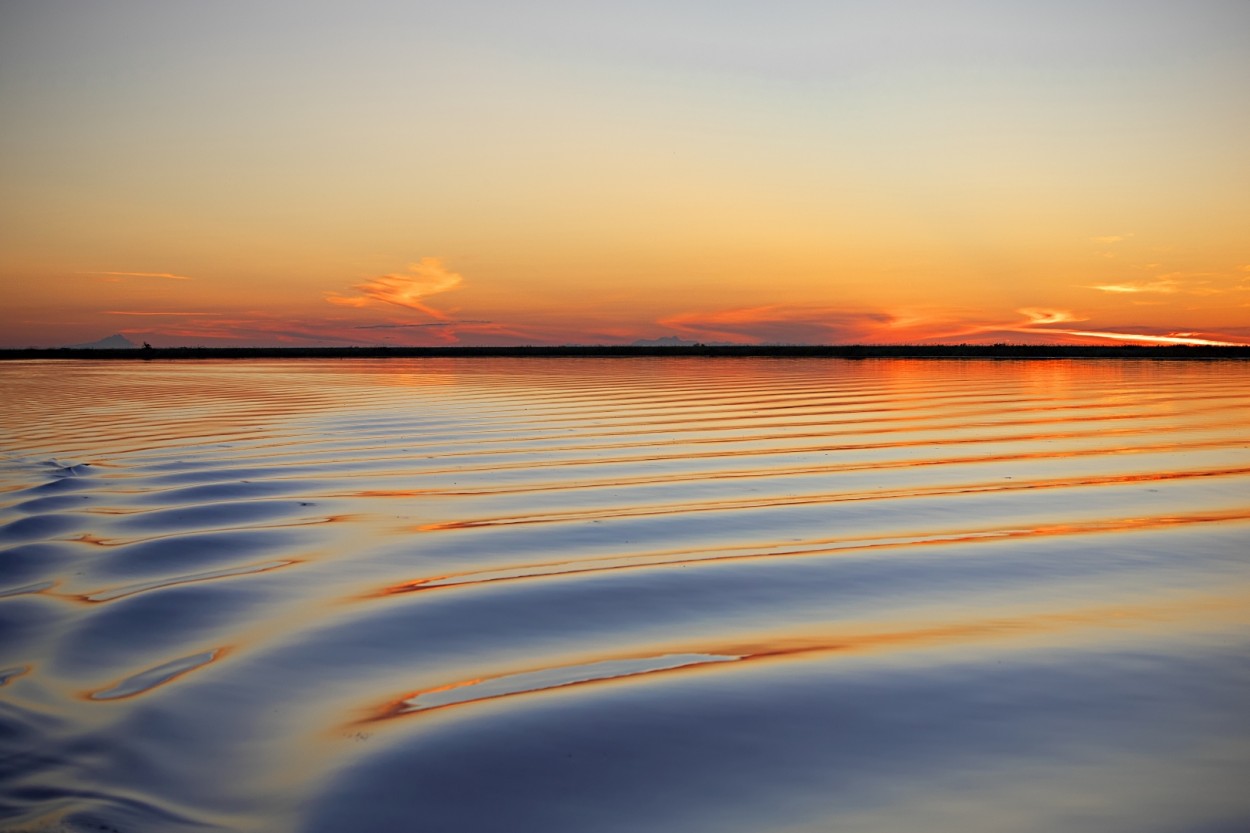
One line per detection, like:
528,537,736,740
0,344,1250,361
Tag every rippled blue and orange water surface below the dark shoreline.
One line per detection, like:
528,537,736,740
0,359,1250,833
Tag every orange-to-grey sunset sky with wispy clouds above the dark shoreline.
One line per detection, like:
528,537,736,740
0,0,1250,346
